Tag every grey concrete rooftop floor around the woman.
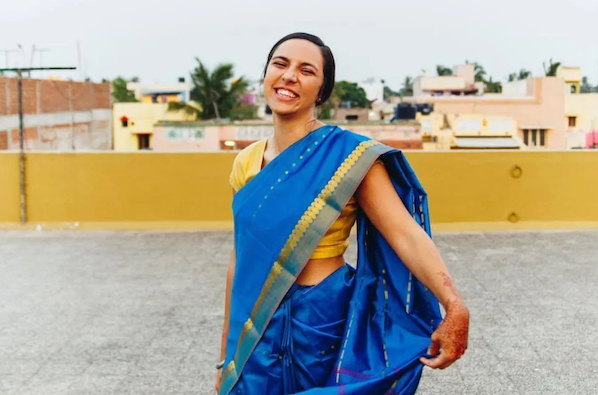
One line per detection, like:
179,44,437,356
0,231,598,395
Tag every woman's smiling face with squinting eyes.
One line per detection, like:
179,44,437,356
264,39,324,115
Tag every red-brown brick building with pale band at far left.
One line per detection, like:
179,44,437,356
0,76,112,151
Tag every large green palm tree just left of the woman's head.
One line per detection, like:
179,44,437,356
191,58,248,119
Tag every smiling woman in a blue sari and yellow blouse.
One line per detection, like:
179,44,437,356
216,33,469,395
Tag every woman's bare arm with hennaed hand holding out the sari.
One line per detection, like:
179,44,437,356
355,163,469,369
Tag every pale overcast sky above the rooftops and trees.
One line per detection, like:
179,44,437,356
0,0,598,89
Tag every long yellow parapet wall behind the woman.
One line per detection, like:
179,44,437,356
0,151,598,230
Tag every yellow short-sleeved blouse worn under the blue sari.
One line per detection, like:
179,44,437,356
230,139,357,259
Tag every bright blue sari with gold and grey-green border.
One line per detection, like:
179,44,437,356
220,125,441,395
